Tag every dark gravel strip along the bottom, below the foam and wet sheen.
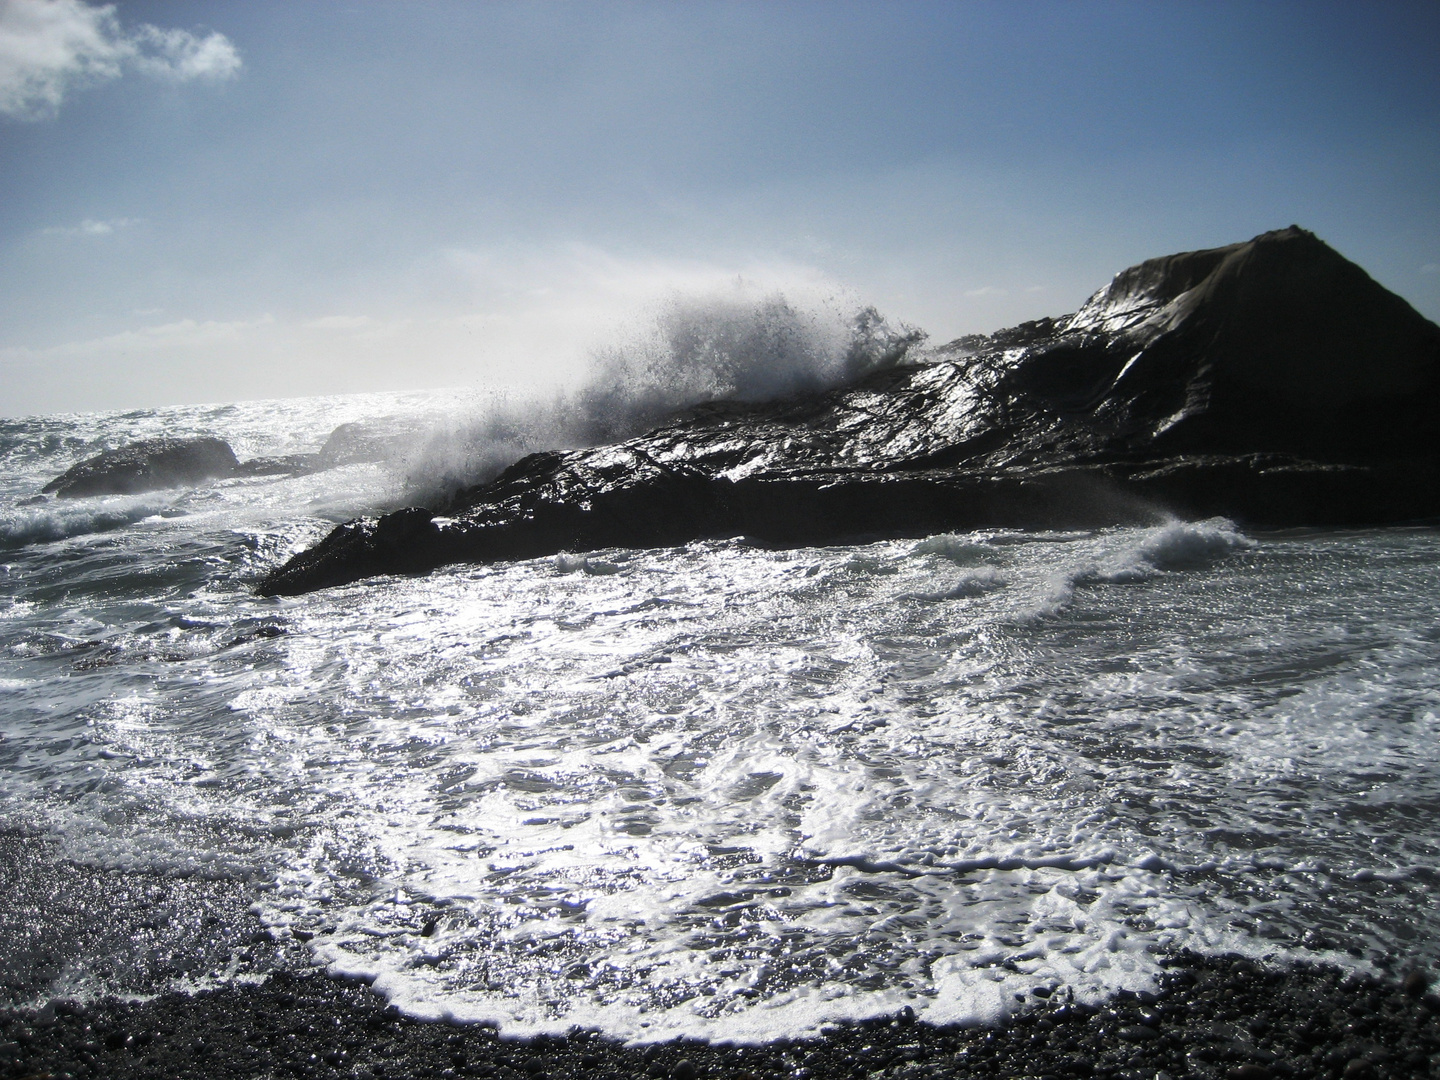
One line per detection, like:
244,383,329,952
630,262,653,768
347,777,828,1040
0,955,1440,1080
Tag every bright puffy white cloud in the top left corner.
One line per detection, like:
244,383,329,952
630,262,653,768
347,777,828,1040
0,0,240,120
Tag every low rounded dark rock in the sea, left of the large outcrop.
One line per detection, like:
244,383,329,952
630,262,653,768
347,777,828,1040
43,436,239,498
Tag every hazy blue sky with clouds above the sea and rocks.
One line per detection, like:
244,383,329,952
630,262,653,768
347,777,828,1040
0,0,1440,416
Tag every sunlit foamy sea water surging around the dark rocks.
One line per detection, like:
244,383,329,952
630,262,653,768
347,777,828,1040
0,395,1440,1040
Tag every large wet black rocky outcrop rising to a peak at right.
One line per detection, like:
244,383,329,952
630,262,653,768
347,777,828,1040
261,228,1440,593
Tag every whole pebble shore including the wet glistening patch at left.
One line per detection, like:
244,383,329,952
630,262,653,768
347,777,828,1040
0,831,1440,1080
